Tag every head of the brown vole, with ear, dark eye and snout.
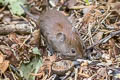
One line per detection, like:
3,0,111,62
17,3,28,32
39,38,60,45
55,32,84,58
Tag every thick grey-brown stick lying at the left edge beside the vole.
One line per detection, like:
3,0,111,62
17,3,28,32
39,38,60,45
0,23,33,35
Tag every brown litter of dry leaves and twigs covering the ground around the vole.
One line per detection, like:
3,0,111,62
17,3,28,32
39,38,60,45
0,0,120,80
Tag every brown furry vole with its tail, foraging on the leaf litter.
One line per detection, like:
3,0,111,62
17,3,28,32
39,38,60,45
22,4,84,59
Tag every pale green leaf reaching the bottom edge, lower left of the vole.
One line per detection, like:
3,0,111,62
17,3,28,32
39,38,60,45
20,56,42,80
